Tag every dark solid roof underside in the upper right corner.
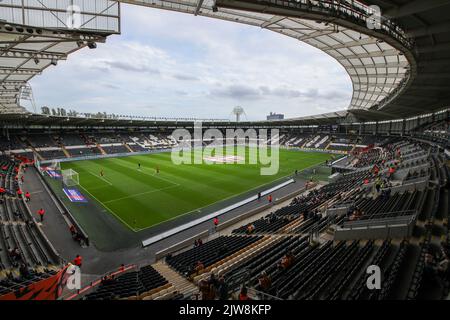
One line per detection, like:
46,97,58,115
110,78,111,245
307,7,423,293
358,0,450,117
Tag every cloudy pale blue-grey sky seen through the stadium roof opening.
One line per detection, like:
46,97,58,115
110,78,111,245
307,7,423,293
31,5,352,120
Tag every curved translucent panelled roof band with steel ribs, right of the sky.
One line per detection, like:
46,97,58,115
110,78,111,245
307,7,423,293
121,0,416,117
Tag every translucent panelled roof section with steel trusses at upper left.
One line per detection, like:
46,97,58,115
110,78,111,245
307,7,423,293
0,0,120,114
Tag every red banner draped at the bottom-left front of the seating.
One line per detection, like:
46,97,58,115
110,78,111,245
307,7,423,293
0,267,67,300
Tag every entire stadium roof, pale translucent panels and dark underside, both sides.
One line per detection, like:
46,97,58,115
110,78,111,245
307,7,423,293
0,0,450,120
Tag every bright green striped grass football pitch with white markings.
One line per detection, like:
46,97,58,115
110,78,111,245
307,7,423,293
61,149,332,231
